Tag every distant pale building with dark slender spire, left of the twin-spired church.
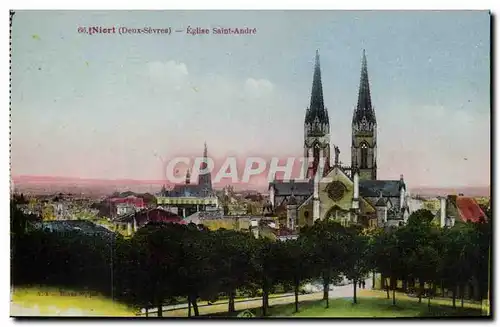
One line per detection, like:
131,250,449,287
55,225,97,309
157,143,219,218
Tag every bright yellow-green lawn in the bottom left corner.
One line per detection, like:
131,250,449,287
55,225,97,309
11,287,135,317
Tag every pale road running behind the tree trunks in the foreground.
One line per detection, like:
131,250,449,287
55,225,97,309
141,277,372,317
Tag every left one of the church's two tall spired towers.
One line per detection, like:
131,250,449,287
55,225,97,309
303,50,330,178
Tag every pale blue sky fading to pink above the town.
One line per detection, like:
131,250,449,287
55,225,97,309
11,11,491,187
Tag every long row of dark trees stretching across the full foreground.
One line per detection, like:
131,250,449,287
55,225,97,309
12,202,491,315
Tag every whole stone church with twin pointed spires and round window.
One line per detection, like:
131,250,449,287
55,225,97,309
269,50,410,231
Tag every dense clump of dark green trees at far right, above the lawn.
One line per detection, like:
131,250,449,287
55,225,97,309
371,210,492,307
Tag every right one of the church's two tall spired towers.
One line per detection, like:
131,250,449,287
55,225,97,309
351,50,377,180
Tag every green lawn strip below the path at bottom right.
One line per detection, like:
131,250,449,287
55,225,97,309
212,297,481,318
